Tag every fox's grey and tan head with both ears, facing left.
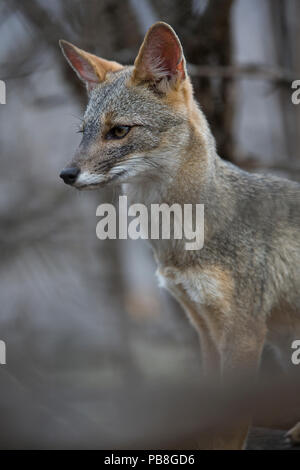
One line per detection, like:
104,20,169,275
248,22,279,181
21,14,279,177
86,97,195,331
60,22,212,189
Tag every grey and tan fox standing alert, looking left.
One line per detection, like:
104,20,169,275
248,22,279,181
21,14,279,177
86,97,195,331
60,21,300,450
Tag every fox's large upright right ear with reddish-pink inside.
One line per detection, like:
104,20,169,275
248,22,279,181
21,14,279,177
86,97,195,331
132,21,186,92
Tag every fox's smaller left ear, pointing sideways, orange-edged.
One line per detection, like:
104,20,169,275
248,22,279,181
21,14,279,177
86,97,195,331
59,39,123,91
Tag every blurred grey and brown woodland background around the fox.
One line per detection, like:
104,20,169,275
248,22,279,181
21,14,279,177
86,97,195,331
0,0,300,449
